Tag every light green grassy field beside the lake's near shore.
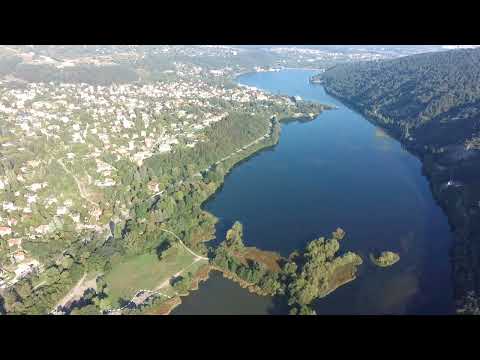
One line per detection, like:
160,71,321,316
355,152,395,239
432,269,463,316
105,245,205,307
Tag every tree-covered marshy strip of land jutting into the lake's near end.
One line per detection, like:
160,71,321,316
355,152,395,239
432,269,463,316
211,221,363,315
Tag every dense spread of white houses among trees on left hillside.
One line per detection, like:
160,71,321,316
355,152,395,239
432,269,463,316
0,59,298,290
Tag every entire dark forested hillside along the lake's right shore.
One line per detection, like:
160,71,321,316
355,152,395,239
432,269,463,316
321,49,480,313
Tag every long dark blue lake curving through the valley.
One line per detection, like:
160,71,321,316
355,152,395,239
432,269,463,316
173,70,453,314
